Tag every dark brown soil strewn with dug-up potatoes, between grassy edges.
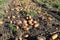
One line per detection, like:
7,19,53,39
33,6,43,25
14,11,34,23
0,0,60,40
